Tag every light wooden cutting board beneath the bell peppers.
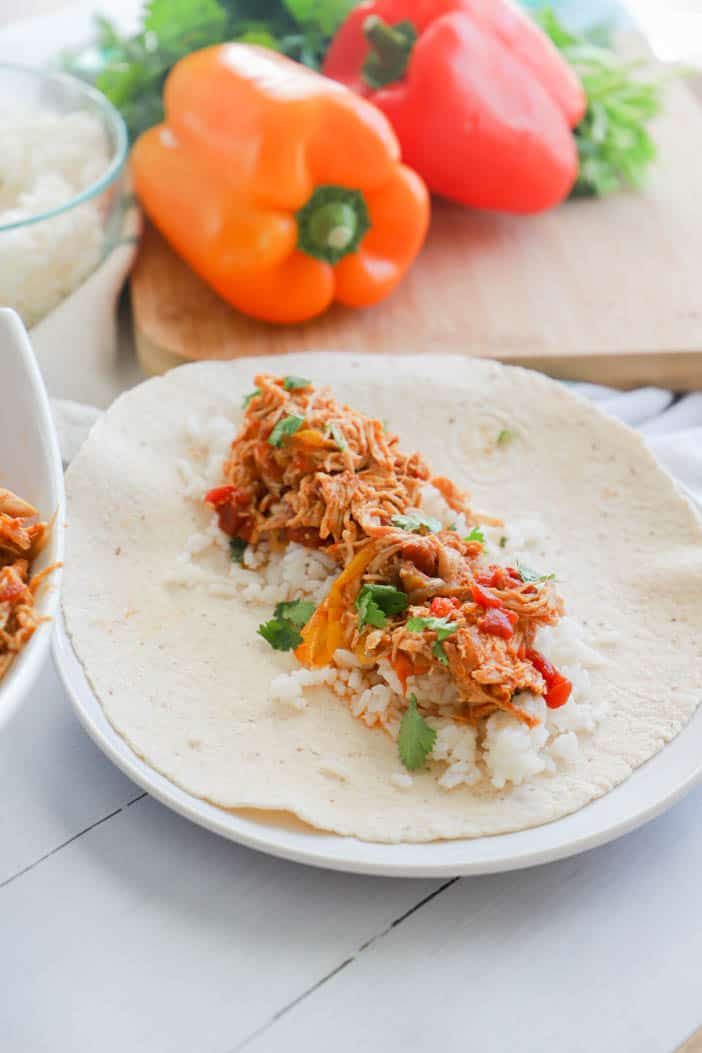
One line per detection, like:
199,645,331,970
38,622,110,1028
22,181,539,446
132,83,702,390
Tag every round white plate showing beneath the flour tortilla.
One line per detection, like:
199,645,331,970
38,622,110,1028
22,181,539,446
54,602,702,877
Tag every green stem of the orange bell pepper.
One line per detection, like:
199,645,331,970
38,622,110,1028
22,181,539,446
297,184,370,263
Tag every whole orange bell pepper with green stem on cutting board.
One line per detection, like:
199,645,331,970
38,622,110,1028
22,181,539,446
132,44,429,322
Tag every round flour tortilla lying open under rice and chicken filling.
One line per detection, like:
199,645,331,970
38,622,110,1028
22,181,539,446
63,354,702,841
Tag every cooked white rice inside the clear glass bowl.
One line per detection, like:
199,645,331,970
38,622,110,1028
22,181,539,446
0,108,109,326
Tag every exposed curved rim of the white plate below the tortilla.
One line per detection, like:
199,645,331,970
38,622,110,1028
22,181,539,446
53,611,702,878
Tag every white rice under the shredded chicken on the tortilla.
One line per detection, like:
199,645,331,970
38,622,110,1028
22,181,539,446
168,413,611,791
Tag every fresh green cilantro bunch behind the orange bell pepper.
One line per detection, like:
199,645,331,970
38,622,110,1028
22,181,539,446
64,0,353,139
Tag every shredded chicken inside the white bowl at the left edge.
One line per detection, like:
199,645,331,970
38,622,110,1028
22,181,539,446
0,489,46,680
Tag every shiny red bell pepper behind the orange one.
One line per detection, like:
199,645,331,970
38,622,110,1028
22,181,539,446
323,0,585,213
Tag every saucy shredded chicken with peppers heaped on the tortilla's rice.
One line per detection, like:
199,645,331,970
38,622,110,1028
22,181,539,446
205,375,569,727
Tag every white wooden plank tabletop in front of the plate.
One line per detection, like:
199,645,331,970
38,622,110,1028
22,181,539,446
0,663,702,1053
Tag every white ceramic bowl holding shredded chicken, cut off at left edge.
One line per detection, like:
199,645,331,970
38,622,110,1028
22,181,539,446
0,307,65,724
